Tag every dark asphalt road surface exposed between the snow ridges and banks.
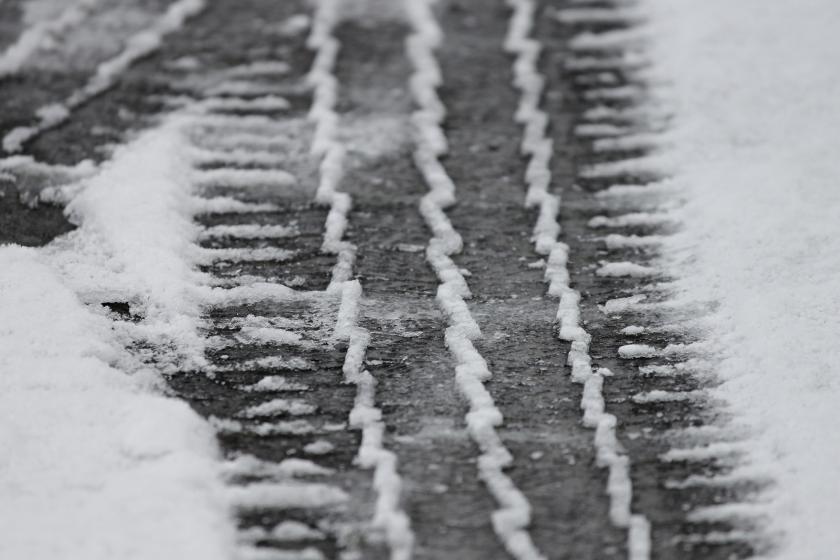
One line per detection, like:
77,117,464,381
0,0,760,560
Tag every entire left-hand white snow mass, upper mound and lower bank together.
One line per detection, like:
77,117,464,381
0,123,235,560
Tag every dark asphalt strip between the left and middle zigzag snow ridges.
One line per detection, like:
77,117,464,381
337,12,507,560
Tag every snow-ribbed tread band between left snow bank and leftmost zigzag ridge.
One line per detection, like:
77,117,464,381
171,84,362,559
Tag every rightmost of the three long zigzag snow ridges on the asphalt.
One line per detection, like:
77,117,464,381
504,0,650,560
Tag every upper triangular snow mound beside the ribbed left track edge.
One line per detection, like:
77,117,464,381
46,119,205,369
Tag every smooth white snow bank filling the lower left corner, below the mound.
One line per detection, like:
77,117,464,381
0,246,234,560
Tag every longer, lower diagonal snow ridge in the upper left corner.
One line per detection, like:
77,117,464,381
3,0,205,152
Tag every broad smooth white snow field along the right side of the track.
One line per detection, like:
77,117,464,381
643,0,840,560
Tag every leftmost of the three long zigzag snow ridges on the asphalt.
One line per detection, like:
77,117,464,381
308,0,414,560
